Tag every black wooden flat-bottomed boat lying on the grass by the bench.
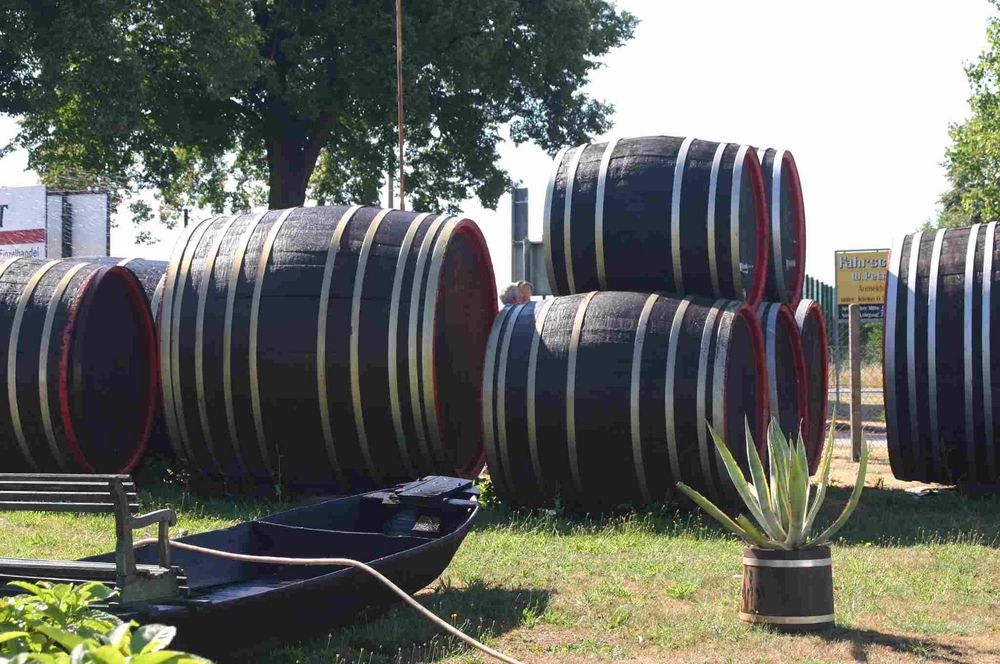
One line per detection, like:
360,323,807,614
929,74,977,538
92,477,479,661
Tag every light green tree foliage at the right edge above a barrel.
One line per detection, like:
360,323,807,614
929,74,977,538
934,0,1000,228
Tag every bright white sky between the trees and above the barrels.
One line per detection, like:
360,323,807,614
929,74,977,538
0,0,991,283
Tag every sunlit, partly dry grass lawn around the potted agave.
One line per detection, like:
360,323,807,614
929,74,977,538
0,447,1000,664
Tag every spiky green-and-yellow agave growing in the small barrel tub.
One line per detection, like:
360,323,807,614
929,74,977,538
677,421,868,550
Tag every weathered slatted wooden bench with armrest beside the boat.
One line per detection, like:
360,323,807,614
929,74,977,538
0,473,186,606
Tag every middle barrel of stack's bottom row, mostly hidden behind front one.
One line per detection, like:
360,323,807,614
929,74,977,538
757,302,809,448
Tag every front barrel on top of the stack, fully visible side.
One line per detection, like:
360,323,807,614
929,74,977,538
542,136,768,304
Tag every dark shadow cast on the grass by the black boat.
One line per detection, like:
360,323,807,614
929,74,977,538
261,582,551,664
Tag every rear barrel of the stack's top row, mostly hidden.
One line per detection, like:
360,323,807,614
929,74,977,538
757,148,806,308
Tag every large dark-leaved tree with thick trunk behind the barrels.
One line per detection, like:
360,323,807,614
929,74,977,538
0,0,636,231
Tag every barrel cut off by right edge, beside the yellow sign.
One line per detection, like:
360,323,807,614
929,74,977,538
883,222,1000,483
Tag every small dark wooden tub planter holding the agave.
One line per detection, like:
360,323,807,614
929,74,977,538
740,546,834,632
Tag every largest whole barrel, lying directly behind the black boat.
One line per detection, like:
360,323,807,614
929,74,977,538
159,206,497,490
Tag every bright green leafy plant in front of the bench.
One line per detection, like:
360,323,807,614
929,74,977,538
0,581,208,664
